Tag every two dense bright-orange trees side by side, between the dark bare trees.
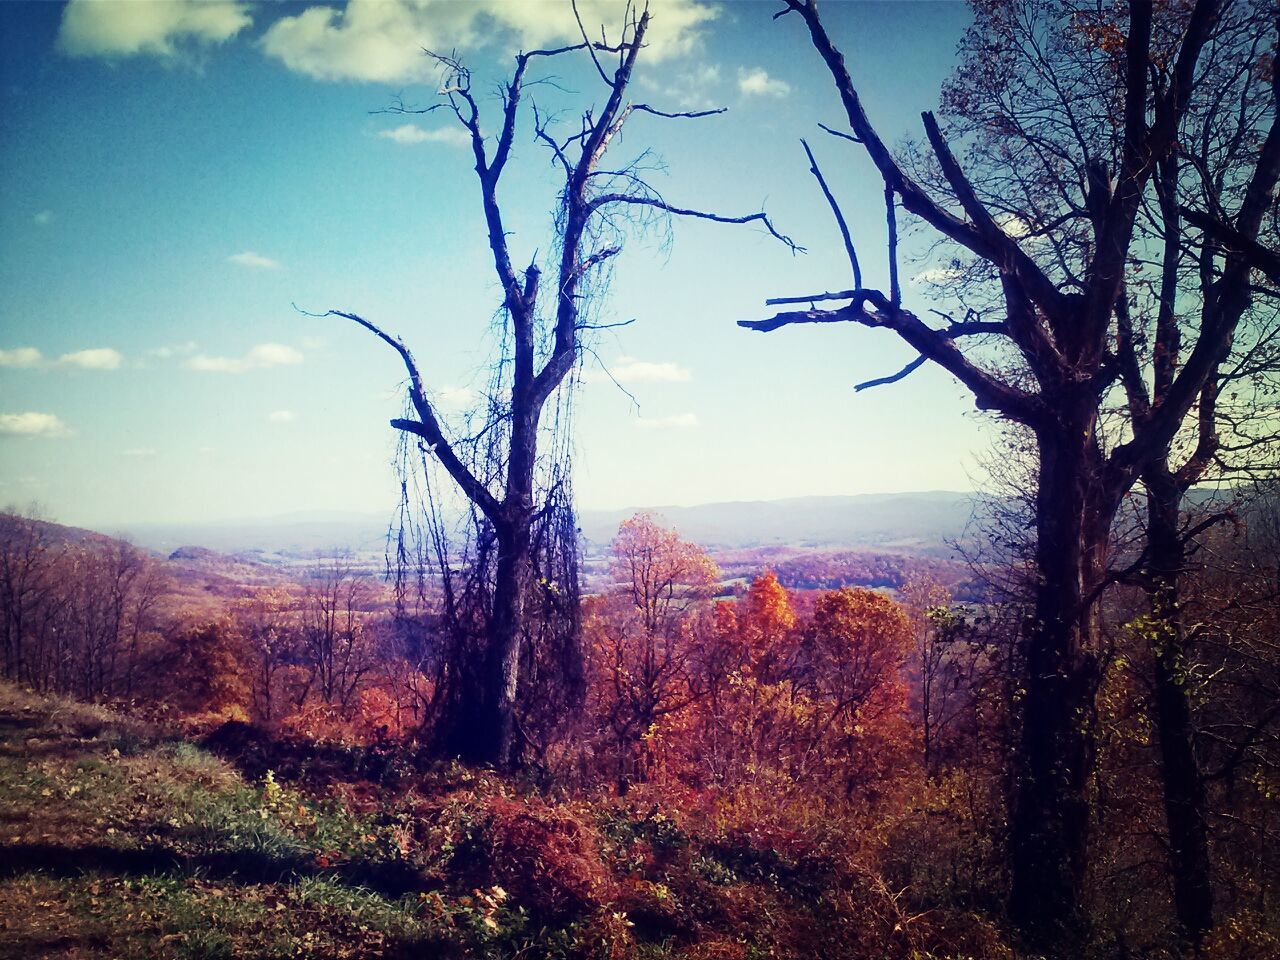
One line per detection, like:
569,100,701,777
687,573,911,829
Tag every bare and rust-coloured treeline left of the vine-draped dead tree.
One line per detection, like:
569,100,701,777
0,512,413,737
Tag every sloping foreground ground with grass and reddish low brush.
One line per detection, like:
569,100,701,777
0,682,1009,960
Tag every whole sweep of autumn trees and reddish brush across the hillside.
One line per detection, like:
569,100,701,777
0,506,1277,960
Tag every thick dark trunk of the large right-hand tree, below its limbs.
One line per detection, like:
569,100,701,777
1009,414,1111,956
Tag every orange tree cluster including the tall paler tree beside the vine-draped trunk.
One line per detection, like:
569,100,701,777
586,515,911,818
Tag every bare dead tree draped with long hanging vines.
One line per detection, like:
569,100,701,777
329,12,795,768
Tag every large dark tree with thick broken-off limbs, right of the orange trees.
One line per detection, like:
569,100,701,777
740,0,1280,954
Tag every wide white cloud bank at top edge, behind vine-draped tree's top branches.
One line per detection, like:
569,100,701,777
262,0,717,83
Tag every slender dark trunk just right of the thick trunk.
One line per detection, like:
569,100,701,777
1144,463,1213,947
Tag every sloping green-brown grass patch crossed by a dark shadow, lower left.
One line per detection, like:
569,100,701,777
0,686,484,960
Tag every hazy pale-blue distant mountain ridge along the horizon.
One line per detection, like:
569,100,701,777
127,490,978,562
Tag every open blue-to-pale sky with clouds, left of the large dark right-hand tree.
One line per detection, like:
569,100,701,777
0,0,987,530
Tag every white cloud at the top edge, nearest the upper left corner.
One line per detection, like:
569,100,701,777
58,0,253,59
